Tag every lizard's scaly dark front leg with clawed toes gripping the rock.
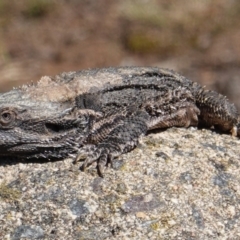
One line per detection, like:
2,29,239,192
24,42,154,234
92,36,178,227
76,111,149,176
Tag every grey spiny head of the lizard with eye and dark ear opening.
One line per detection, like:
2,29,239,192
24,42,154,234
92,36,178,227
0,102,98,159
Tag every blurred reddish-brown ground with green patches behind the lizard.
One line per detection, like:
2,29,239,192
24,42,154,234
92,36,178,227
0,0,240,109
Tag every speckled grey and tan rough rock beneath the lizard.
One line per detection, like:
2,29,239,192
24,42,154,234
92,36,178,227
0,128,240,240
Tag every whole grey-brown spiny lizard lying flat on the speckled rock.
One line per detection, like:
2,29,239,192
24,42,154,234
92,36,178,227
0,67,240,175
